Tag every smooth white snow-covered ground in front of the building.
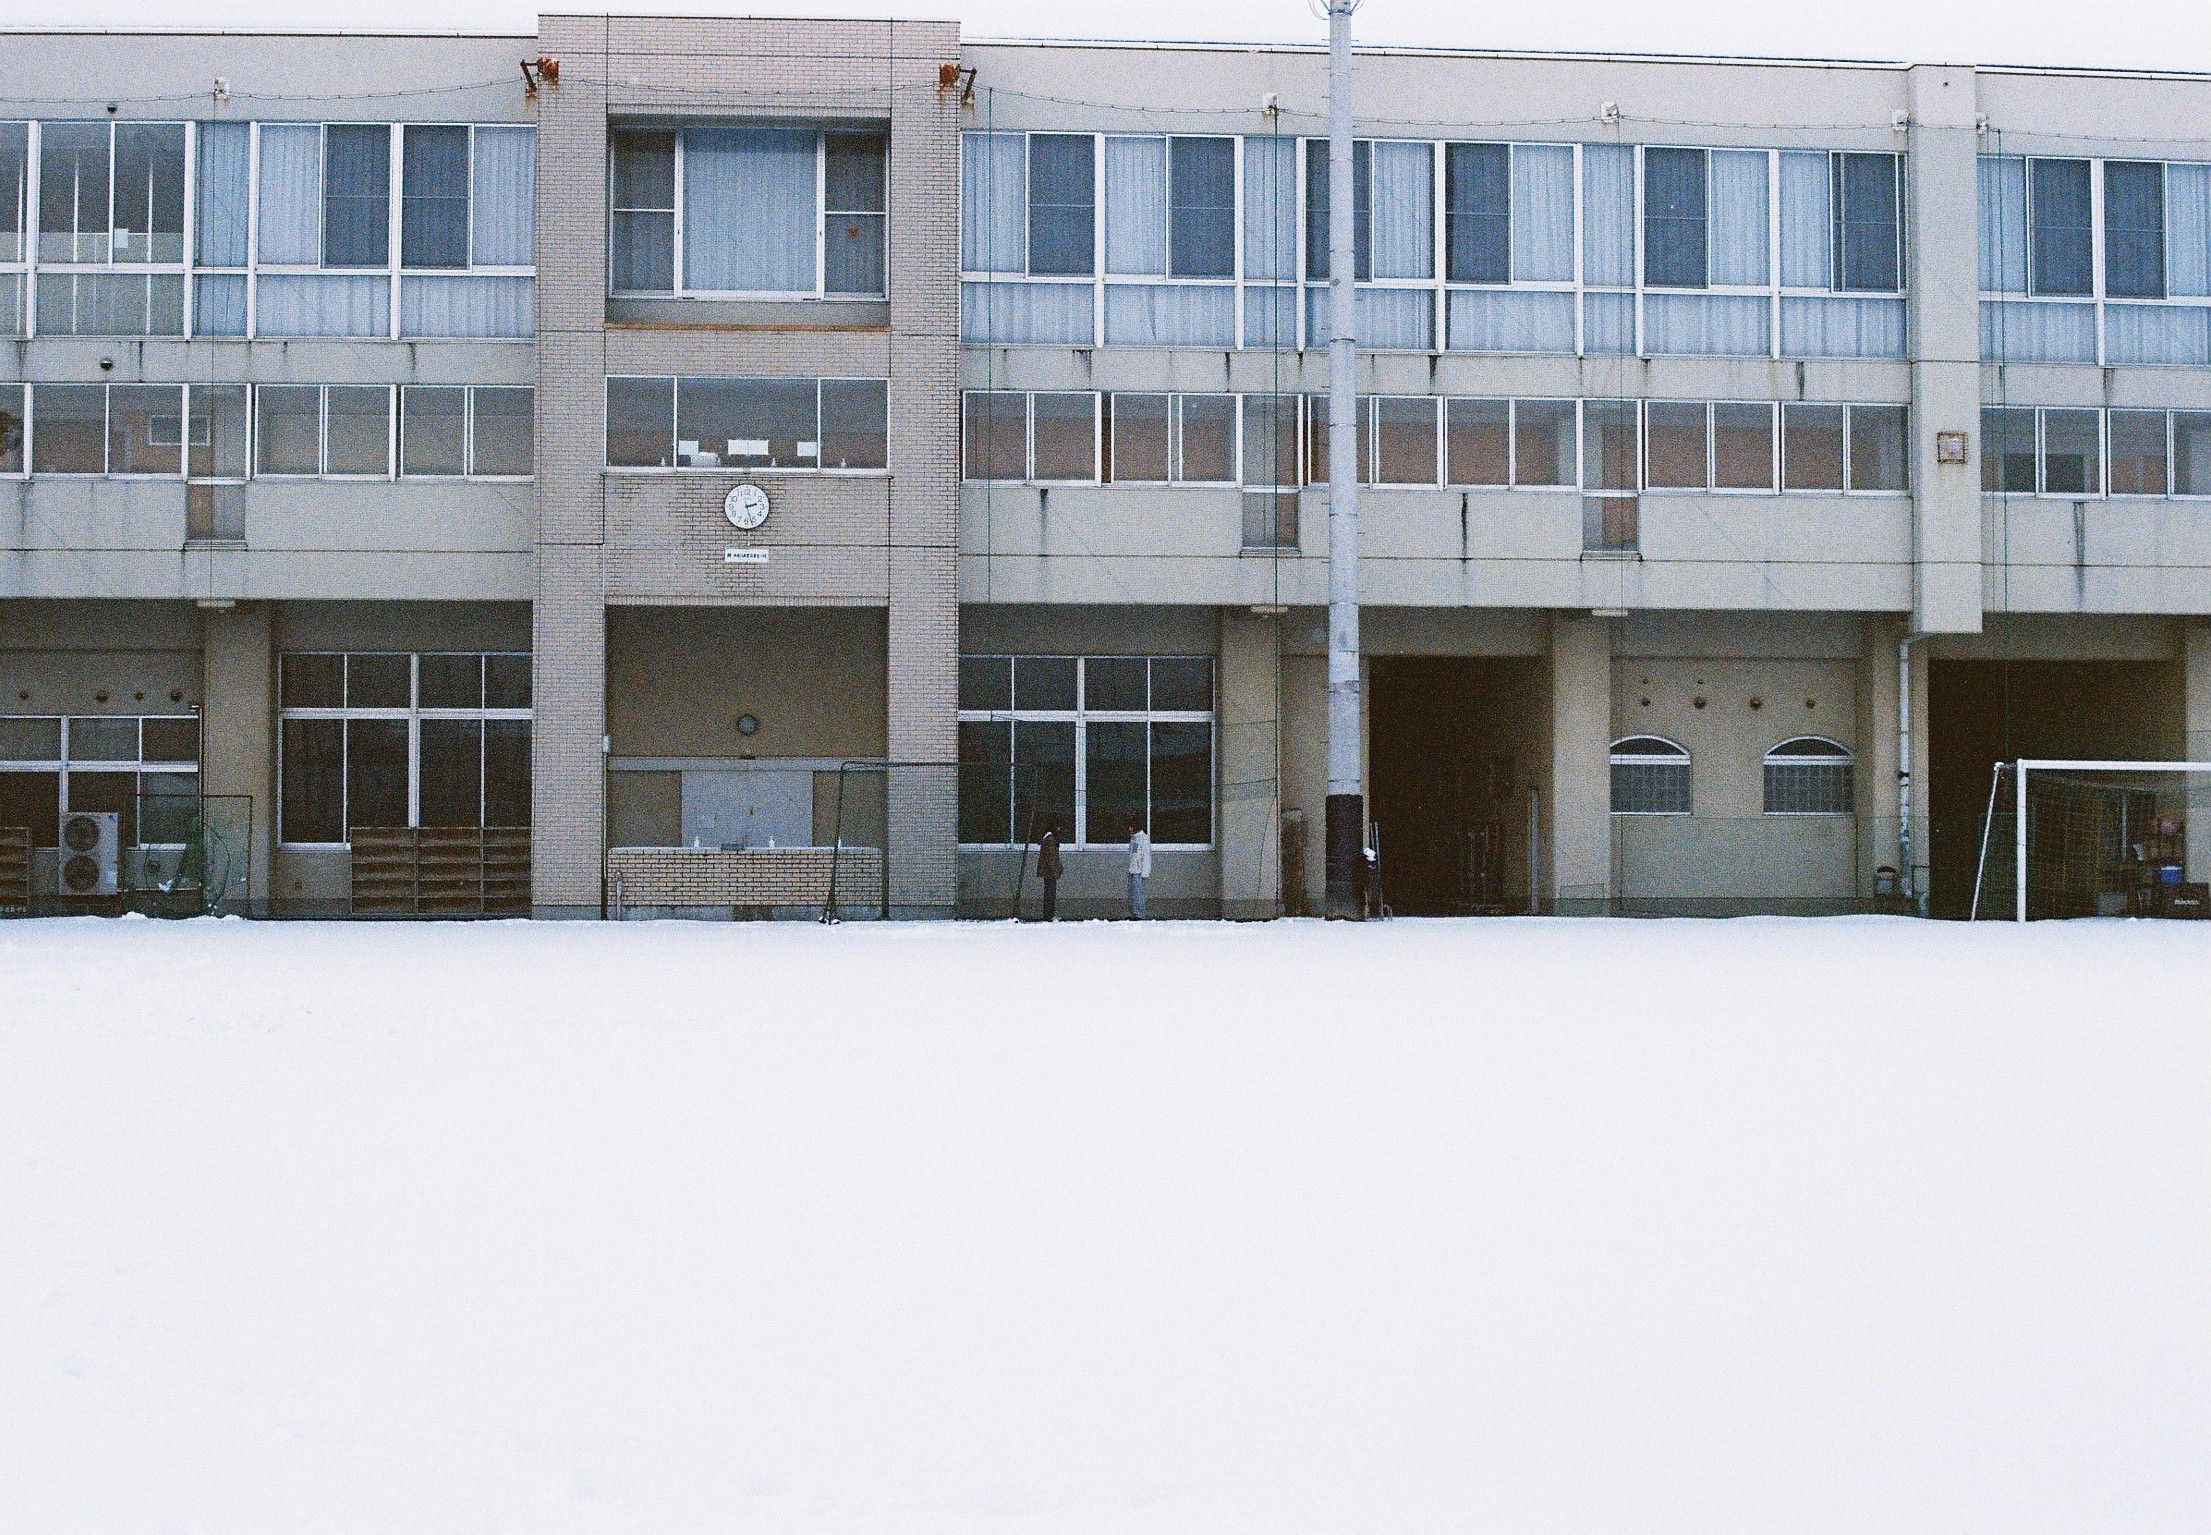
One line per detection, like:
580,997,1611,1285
0,918,2211,1535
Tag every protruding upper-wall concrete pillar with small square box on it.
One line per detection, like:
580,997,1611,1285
1904,64,1981,633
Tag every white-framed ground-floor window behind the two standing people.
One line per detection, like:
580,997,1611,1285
960,655,1214,847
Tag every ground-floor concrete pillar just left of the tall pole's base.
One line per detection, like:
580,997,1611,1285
1220,608,1282,918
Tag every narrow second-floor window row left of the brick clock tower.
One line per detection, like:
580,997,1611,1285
0,383,537,480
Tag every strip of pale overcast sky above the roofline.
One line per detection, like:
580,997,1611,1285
0,0,2211,71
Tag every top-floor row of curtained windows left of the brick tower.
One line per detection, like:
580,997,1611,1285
0,119,537,336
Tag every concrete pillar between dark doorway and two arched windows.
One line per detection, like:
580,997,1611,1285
1545,613,1612,916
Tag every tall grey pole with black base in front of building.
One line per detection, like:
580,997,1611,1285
1327,0,1366,920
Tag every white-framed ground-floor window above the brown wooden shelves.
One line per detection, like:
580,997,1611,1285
279,652,531,845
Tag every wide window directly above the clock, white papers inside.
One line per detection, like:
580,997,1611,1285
606,376,889,469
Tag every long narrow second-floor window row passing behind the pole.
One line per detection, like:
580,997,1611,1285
962,389,1908,493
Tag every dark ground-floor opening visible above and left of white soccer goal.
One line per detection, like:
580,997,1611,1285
1926,661,2182,918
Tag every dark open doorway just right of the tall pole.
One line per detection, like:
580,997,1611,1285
1369,657,1543,916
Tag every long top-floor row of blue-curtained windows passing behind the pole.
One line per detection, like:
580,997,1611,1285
962,133,1904,356
